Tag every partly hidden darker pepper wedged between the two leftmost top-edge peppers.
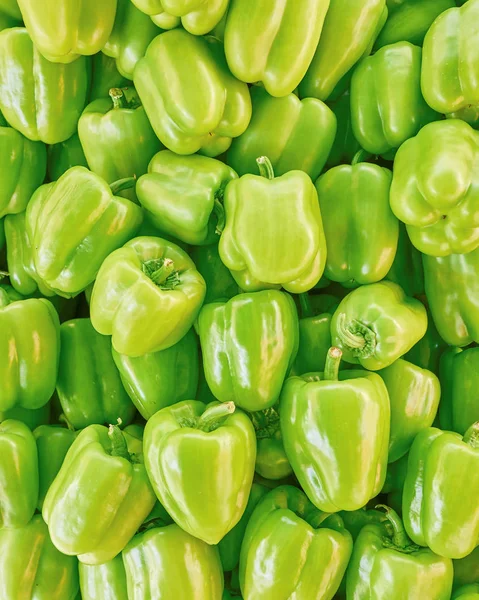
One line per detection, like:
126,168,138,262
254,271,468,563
102,0,161,79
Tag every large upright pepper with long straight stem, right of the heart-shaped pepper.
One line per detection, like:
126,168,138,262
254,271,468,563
280,348,390,512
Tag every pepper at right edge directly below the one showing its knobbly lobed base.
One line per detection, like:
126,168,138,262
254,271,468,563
423,249,479,346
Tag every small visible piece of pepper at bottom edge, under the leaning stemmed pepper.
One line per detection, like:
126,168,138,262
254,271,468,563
78,554,129,600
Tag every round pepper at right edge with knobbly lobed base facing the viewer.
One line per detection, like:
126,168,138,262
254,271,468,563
390,119,479,256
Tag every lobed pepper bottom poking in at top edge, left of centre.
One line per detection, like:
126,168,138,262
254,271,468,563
132,0,229,35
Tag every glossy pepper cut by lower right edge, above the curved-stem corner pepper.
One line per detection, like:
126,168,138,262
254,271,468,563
403,423,479,558
